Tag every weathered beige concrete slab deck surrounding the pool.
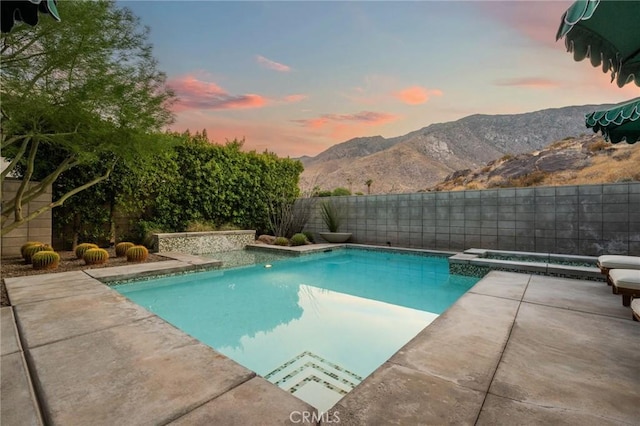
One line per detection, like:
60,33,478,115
0,253,640,425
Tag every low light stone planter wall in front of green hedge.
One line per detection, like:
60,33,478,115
153,231,256,254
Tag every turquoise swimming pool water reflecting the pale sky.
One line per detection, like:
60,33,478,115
116,249,478,412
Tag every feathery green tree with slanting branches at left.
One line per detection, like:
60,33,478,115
0,0,173,235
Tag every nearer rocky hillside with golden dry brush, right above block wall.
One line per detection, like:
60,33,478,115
426,135,640,191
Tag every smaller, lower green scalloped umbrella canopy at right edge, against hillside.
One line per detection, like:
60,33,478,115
586,98,640,143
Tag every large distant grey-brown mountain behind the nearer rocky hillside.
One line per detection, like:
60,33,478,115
300,105,608,193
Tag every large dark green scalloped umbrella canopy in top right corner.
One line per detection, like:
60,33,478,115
556,0,640,87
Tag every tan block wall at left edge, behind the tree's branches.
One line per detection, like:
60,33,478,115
2,178,51,257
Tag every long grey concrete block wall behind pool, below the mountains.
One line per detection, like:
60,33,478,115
305,182,640,256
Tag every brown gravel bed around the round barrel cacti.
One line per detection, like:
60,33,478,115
0,248,169,306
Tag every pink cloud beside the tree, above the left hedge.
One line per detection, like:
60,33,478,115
167,75,268,112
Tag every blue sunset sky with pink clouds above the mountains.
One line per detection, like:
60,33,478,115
118,0,640,157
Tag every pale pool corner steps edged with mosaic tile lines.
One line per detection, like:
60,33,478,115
264,351,362,408
